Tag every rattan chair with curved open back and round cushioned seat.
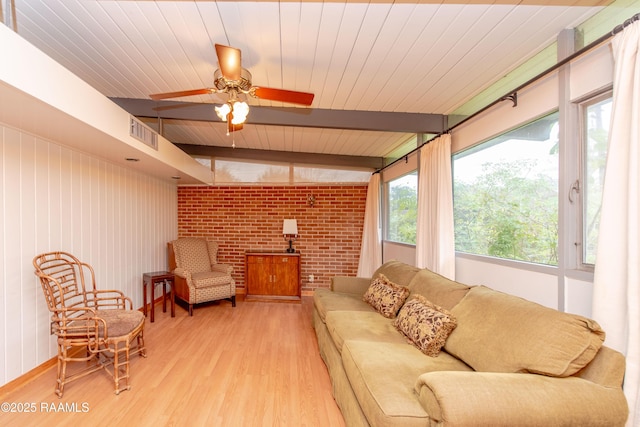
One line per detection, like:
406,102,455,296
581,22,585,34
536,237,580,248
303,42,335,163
33,252,146,397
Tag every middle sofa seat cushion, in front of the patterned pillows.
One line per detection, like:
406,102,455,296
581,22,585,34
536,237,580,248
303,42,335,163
325,311,407,352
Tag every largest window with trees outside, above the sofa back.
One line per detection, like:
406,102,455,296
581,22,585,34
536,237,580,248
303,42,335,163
453,112,558,265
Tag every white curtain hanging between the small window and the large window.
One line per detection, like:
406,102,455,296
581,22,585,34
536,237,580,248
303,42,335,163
416,134,455,280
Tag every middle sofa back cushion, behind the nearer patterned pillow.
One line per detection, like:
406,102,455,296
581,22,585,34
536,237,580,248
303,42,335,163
409,269,471,310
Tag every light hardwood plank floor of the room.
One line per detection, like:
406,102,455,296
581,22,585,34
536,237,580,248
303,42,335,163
0,297,344,427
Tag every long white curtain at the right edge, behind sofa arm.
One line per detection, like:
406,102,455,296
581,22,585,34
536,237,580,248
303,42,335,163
593,18,640,426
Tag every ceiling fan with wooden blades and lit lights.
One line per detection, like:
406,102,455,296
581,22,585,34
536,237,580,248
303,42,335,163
149,44,314,132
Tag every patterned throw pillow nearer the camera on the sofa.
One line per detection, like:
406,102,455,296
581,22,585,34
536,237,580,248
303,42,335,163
394,295,458,356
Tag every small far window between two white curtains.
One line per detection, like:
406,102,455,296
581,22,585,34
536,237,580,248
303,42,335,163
386,171,418,245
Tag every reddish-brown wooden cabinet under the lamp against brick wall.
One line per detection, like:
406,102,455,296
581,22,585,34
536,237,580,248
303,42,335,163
244,252,301,301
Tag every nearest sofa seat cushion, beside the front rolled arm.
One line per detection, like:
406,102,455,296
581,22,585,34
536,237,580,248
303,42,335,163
342,340,471,426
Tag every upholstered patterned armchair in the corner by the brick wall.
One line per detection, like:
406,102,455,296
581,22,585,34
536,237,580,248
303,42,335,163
168,237,236,316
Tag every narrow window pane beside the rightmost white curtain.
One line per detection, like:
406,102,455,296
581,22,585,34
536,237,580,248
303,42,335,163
580,93,612,266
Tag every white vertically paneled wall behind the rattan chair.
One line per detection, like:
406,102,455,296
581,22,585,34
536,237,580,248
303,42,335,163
0,123,178,386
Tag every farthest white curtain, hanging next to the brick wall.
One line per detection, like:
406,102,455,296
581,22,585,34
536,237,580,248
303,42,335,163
358,173,382,277
